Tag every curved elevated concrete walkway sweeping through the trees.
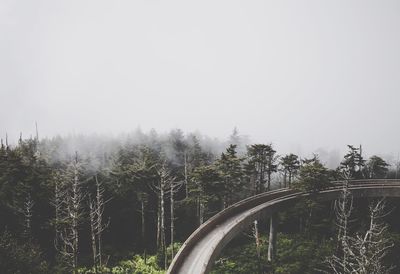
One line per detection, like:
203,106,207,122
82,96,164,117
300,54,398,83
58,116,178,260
167,180,400,274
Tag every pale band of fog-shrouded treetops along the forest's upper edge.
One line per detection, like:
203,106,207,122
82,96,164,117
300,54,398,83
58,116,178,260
1,127,400,180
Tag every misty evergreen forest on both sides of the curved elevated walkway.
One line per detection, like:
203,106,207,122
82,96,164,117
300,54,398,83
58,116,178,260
0,129,400,274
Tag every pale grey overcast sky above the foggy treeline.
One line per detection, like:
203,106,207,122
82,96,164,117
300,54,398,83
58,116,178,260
0,0,400,158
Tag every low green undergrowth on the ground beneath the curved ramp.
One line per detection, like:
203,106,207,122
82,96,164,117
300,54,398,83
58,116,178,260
212,233,334,274
